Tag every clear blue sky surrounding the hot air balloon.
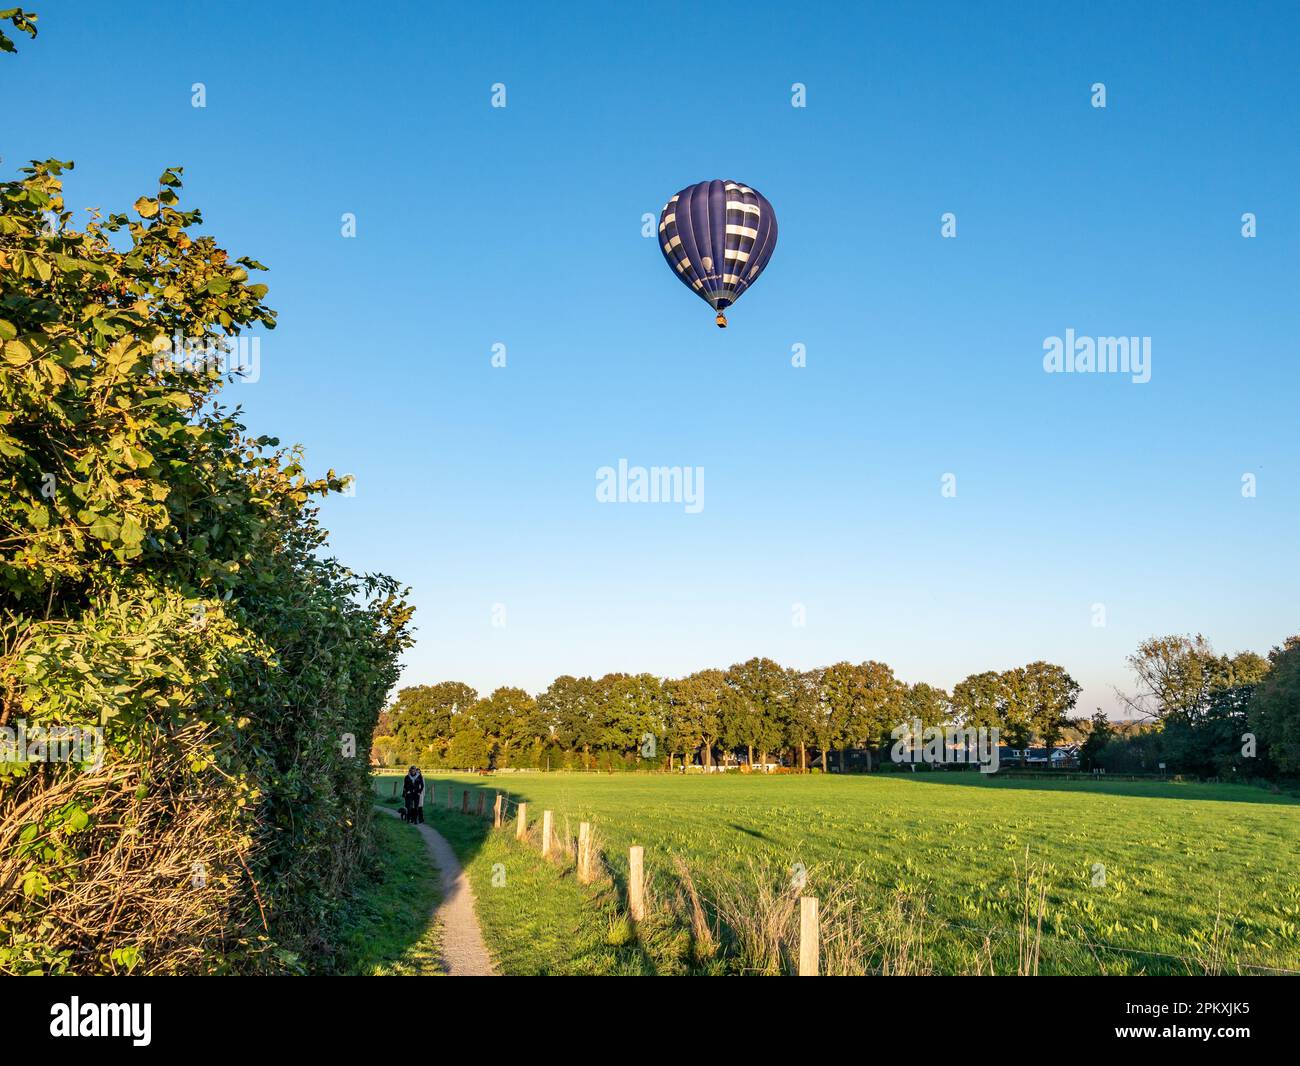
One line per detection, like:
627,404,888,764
0,0,1300,712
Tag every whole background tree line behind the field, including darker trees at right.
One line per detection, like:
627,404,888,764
374,636,1300,776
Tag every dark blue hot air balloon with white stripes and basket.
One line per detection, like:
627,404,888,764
659,181,776,326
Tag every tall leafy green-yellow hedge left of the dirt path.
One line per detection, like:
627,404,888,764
0,160,411,972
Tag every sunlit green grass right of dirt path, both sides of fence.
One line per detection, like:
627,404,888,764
376,774,1300,974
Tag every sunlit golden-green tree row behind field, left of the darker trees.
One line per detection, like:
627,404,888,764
374,658,1079,770
